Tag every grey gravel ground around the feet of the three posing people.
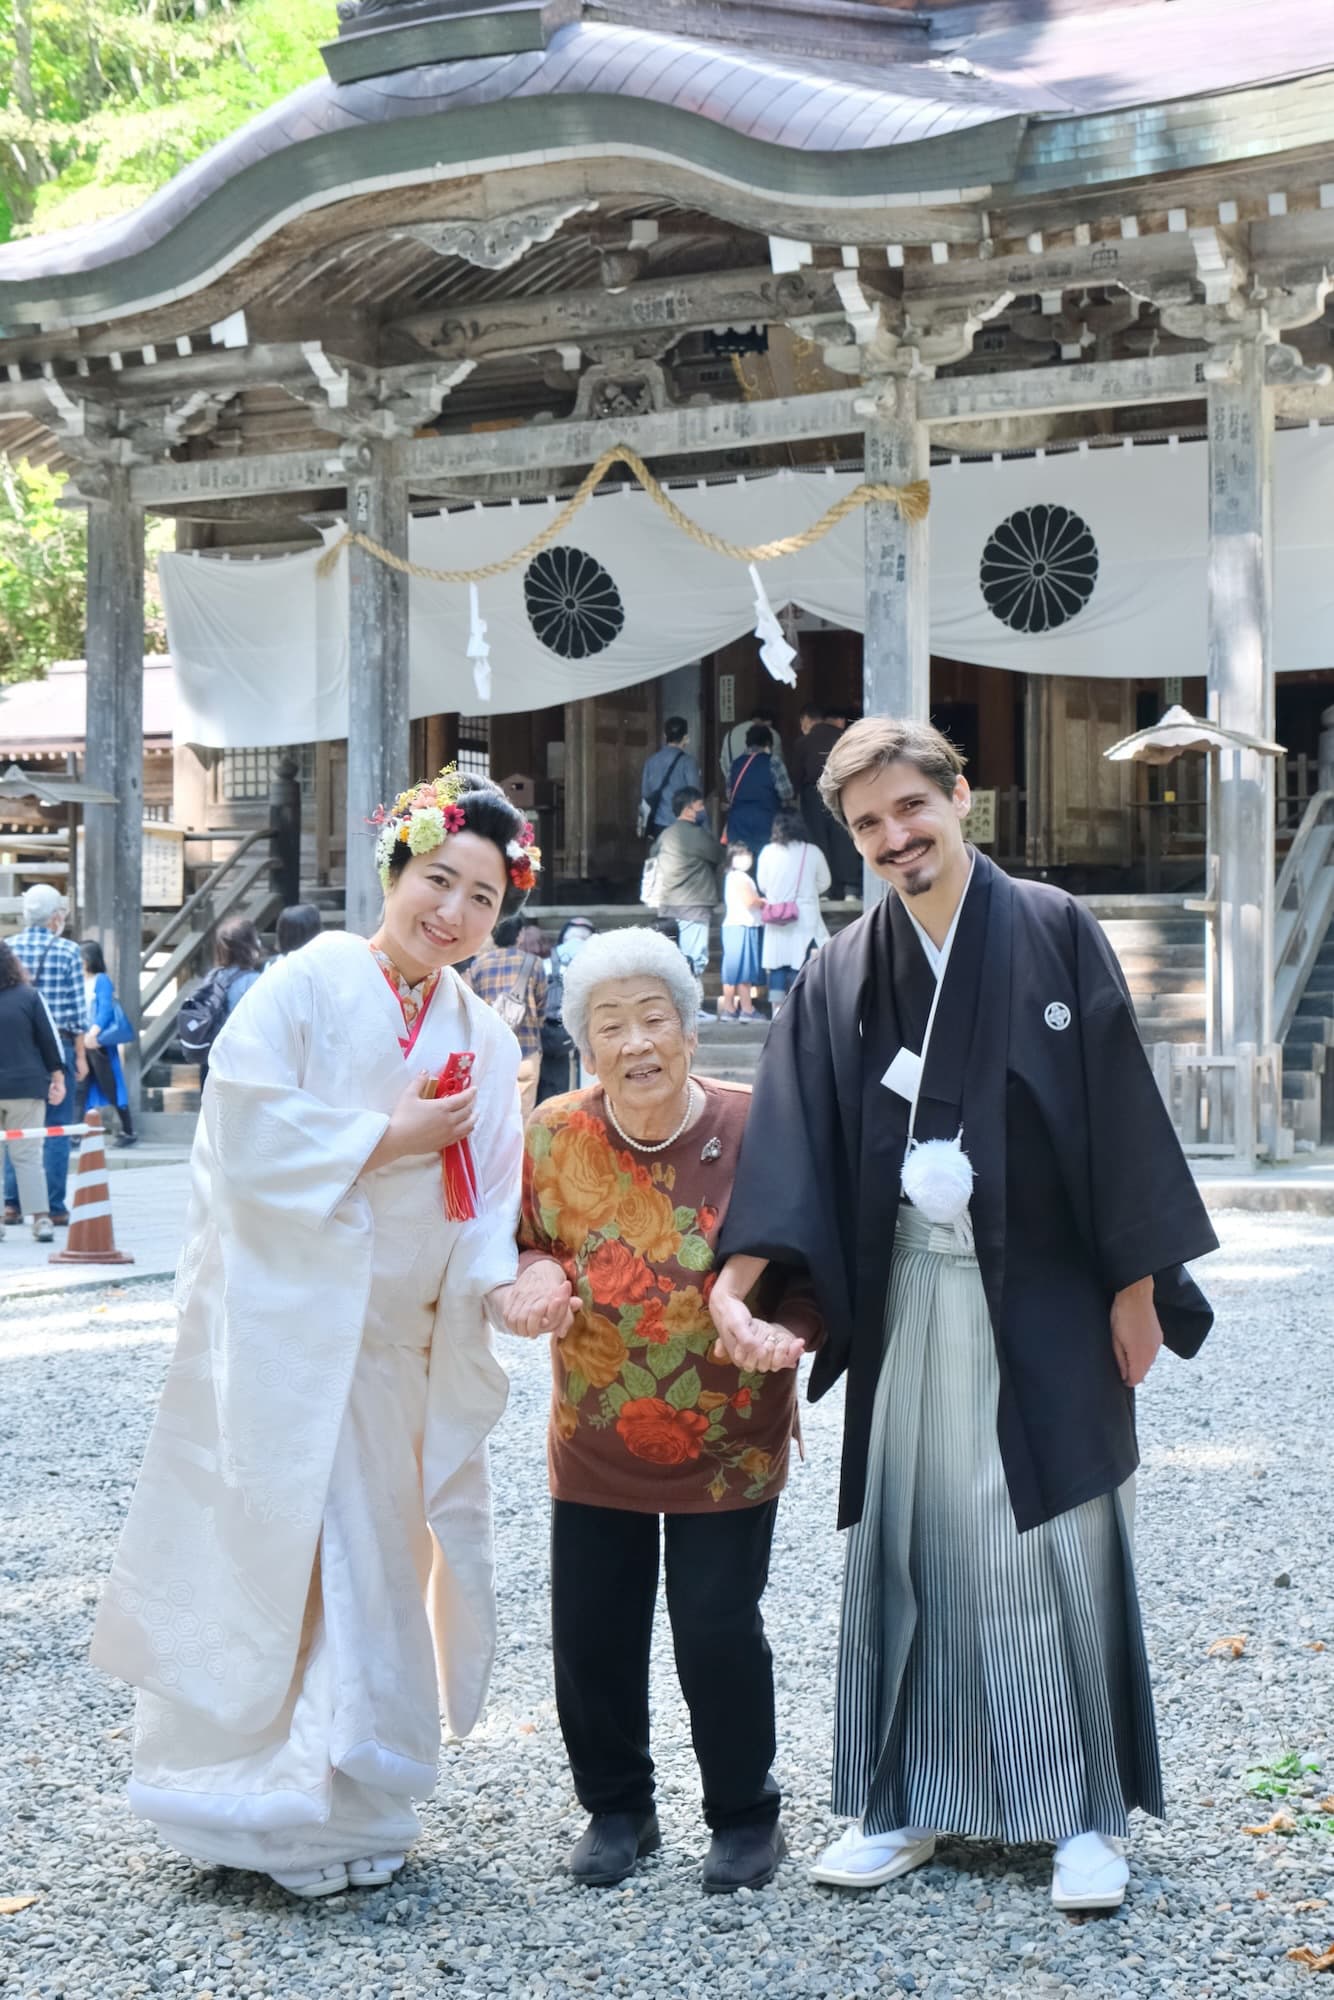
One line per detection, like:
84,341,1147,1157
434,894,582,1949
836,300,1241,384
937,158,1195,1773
0,1216,1334,2000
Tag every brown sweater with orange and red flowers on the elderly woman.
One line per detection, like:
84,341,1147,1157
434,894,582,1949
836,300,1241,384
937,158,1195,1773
518,1078,822,1514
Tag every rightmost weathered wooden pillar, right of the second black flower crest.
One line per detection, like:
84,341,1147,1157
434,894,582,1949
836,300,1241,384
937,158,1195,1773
1208,340,1274,1054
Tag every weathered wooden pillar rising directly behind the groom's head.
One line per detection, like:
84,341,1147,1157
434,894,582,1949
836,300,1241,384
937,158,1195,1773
862,376,930,908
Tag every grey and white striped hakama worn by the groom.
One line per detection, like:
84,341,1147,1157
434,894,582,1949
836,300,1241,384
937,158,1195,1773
834,1206,1162,1842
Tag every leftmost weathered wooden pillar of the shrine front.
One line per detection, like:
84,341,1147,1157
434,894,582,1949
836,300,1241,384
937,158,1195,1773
84,466,144,1072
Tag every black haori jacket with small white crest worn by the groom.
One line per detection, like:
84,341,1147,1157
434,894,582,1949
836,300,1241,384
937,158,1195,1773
718,854,1218,1530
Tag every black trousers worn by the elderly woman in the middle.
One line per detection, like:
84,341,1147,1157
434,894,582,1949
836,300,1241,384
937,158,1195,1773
552,1500,780,1830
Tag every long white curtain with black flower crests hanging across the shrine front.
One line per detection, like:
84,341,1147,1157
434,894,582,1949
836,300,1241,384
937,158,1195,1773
158,430,1334,748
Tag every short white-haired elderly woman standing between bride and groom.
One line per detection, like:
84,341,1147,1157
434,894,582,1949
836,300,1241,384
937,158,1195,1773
498,930,820,1890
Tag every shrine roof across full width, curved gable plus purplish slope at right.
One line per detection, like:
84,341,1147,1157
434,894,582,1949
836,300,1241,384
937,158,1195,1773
0,0,1334,336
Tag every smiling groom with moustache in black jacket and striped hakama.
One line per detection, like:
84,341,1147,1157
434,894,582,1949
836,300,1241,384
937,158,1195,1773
712,718,1216,1908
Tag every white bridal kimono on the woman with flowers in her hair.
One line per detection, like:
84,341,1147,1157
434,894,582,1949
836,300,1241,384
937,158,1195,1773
92,934,522,1872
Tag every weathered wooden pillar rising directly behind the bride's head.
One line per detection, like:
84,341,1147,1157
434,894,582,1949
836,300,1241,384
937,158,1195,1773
346,442,414,936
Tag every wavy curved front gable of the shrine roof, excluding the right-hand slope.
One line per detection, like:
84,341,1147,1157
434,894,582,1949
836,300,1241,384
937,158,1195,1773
0,22,1022,326
